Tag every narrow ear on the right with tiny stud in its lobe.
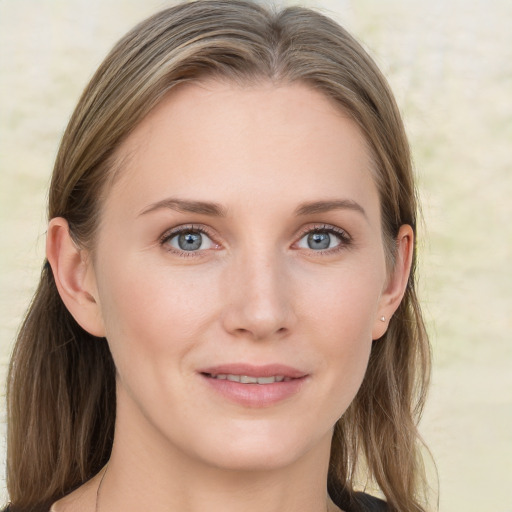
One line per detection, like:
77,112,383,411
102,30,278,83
372,225,414,340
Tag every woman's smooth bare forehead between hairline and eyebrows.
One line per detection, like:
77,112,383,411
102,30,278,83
107,80,378,221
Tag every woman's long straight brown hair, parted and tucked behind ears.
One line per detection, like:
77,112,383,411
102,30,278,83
7,0,430,512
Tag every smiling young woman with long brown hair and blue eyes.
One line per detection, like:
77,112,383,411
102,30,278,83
7,0,429,512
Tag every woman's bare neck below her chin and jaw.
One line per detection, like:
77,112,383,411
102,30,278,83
99,400,338,512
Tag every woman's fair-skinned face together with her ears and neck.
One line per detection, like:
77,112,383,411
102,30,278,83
47,81,413,512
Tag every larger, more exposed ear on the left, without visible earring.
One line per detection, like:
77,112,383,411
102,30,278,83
46,217,105,337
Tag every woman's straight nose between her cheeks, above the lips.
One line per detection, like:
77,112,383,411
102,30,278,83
222,251,296,340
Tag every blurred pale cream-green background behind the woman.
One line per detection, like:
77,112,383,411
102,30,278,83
0,0,512,512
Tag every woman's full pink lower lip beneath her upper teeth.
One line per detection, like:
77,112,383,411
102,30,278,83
201,374,306,408
